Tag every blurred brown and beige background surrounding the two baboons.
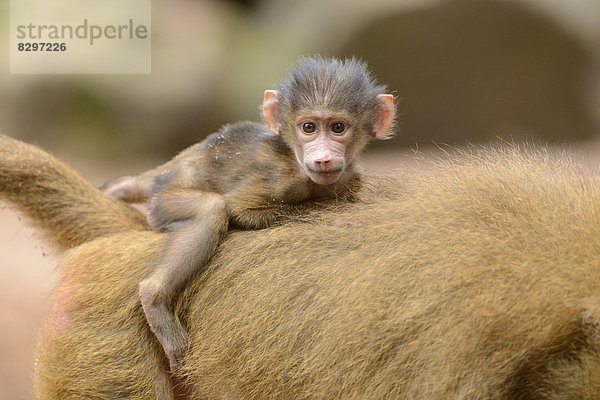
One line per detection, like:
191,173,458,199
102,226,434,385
0,0,600,400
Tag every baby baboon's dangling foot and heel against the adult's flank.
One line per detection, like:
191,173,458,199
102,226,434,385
139,280,188,371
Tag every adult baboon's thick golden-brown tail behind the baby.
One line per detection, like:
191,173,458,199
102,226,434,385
0,135,146,249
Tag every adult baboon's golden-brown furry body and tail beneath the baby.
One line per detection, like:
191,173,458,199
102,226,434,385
0,137,600,399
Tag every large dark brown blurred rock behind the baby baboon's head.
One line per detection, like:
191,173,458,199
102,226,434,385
339,0,598,146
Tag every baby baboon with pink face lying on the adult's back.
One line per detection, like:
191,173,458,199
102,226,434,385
104,54,395,367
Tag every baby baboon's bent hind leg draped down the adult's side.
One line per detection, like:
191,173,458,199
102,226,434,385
140,189,229,368
